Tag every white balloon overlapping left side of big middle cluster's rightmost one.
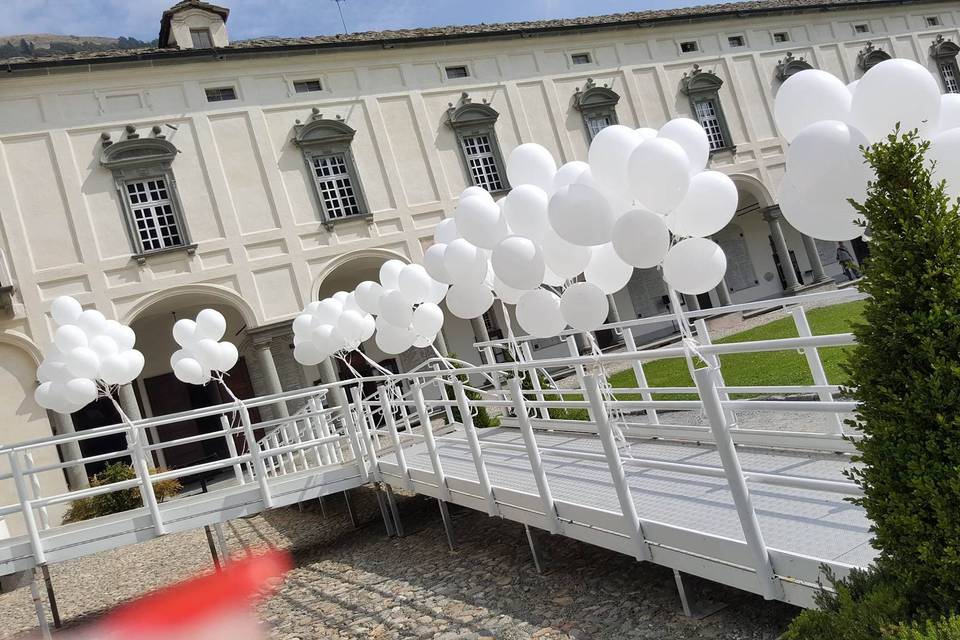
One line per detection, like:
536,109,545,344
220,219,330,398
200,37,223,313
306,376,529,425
627,138,690,213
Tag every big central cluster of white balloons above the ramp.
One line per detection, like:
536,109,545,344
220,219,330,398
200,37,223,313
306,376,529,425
423,118,737,337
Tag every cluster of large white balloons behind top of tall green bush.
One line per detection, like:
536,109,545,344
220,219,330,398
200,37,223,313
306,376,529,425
774,58,960,241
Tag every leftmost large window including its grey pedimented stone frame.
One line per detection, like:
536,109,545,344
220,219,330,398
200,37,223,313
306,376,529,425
100,130,196,264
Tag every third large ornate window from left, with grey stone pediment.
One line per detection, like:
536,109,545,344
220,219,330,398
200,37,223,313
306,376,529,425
447,91,510,192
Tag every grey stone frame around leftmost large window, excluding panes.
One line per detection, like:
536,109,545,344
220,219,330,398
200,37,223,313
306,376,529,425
100,125,197,265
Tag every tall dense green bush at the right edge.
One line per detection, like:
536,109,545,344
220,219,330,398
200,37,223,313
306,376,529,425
785,132,960,640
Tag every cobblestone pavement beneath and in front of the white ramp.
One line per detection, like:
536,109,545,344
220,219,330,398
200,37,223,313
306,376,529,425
0,489,797,640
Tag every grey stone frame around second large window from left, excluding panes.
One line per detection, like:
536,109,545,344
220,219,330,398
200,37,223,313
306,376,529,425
293,107,373,231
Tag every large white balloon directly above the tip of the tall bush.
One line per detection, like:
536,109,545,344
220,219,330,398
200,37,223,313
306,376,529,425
852,58,940,142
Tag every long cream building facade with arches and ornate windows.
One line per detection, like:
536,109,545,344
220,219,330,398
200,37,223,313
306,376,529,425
0,0,960,532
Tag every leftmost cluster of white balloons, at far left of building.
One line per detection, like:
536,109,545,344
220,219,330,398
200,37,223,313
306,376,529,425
34,296,144,413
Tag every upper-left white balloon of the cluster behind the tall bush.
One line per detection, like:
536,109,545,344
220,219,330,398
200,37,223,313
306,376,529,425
773,69,851,142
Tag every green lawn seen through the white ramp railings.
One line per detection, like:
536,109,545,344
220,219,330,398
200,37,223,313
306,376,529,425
610,300,864,400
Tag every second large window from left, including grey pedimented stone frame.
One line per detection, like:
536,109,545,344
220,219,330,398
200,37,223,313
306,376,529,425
294,108,368,228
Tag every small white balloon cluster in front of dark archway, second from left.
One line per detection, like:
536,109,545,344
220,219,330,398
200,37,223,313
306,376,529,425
170,309,240,384
